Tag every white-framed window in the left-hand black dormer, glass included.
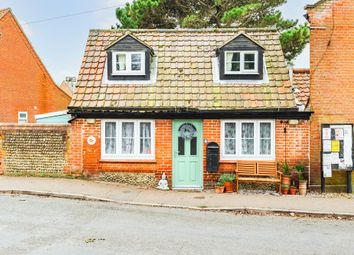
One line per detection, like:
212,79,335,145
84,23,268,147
112,51,145,75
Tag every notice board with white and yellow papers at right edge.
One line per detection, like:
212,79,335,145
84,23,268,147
322,124,354,178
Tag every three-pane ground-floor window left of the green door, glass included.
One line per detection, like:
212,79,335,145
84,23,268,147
101,119,155,159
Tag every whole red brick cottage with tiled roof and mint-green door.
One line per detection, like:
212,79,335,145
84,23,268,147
68,29,310,189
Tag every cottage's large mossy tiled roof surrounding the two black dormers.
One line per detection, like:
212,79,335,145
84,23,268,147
69,29,296,111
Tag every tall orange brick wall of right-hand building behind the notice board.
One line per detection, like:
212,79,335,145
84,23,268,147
308,0,354,185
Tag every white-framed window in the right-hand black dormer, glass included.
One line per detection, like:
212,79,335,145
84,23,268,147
225,51,258,74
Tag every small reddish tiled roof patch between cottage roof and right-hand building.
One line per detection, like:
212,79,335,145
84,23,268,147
293,69,310,106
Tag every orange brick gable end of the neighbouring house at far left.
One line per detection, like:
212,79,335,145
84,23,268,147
0,9,71,123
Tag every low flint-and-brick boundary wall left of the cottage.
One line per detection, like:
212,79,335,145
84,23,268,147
0,124,68,175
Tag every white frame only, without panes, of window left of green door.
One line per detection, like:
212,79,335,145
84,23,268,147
101,119,155,160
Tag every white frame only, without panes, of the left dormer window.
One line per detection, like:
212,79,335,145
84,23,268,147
112,51,145,75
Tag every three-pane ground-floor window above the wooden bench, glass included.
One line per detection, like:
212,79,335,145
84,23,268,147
221,120,275,160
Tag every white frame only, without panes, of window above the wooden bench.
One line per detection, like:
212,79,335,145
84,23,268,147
220,119,276,161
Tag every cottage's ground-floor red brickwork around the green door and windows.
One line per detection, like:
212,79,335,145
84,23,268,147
70,119,309,187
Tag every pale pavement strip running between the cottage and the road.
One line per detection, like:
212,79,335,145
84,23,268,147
0,176,354,218
